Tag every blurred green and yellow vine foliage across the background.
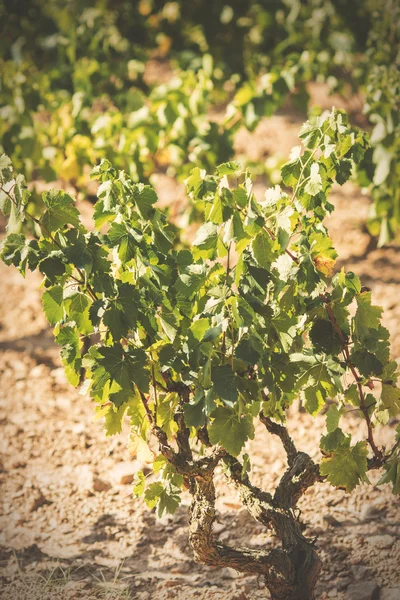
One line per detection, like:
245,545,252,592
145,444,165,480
0,0,400,243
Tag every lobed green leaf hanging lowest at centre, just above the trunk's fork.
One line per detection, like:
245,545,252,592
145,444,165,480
208,406,254,456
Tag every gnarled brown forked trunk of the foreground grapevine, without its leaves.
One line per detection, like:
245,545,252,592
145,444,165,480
189,415,321,600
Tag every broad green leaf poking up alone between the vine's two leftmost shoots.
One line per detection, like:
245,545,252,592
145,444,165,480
40,190,79,233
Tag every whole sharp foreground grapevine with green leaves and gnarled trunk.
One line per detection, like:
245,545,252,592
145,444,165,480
0,110,400,600
